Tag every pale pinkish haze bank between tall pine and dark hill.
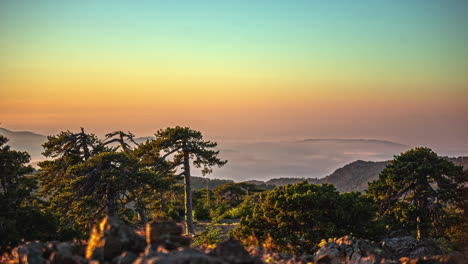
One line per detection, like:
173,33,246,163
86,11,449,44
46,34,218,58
218,139,410,181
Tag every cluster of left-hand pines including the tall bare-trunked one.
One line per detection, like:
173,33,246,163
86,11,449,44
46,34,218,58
32,127,225,237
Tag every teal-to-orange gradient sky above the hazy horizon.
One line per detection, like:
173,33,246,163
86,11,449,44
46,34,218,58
0,0,468,153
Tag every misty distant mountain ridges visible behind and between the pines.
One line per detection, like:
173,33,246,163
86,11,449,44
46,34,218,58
0,128,468,192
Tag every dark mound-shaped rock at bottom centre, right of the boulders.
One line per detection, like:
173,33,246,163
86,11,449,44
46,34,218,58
210,239,262,264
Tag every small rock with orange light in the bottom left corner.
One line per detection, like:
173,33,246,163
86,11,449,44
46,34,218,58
12,241,47,264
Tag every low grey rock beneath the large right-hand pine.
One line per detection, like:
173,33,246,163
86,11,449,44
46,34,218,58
380,236,442,259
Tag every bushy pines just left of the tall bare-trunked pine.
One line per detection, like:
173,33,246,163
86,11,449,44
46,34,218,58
37,129,172,236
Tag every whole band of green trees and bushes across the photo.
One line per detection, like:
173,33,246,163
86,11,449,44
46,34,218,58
0,127,468,254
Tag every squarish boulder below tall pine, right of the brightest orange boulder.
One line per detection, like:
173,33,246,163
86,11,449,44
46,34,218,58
146,221,191,250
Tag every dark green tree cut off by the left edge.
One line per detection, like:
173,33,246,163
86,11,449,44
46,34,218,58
0,135,57,253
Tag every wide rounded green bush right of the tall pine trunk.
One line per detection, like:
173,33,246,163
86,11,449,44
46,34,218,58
230,182,381,253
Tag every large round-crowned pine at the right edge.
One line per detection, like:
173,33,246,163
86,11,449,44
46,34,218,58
367,148,468,242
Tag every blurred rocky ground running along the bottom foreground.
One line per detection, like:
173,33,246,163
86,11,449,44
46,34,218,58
3,218,468,264
